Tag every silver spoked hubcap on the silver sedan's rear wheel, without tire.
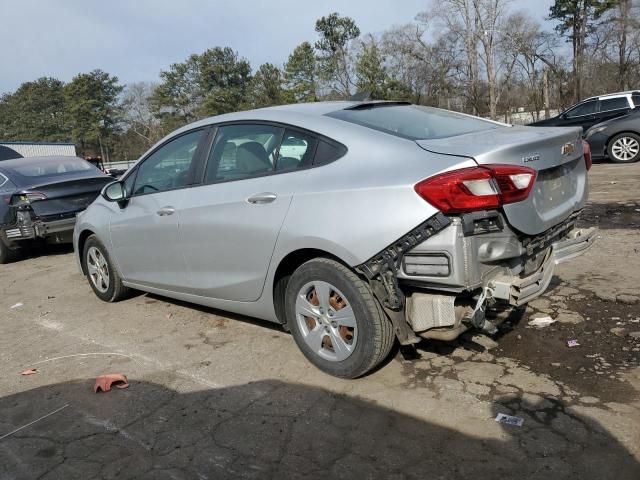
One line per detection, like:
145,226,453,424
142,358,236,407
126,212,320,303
296,280,358,362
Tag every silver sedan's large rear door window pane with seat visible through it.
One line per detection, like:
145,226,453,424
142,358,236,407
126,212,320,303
205,124,283,183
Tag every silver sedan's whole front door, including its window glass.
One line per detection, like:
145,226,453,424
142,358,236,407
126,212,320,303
109,130,204,291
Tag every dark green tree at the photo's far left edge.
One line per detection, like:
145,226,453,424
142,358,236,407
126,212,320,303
0,77,70,141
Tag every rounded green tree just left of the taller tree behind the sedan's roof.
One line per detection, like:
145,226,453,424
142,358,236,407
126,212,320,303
284,42,317,103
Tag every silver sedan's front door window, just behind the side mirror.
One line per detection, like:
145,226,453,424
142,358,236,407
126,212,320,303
133,130,203,195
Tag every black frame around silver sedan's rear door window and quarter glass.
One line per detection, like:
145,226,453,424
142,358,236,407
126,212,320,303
195,120,349,186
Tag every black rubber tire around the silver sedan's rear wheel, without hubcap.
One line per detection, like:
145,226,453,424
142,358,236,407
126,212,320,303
285,258,395,378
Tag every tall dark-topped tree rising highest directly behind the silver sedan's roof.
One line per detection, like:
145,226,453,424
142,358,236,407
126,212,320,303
315,13,360,97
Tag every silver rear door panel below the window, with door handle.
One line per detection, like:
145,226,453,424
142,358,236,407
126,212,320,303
179,170,300,302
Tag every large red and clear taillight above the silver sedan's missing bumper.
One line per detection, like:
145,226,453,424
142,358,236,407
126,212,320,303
414,165,536,213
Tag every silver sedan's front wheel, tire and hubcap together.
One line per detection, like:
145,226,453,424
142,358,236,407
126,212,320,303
82,235,129,302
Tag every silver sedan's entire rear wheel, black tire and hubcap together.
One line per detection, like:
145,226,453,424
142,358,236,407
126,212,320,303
285,258,394,378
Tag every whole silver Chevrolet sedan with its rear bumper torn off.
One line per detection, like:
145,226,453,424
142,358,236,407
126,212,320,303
74,102,595,378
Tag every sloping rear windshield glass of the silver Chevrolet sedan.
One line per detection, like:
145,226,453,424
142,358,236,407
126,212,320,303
327,104,504,140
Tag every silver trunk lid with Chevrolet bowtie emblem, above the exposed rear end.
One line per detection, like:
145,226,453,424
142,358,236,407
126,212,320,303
417,126,588,235
